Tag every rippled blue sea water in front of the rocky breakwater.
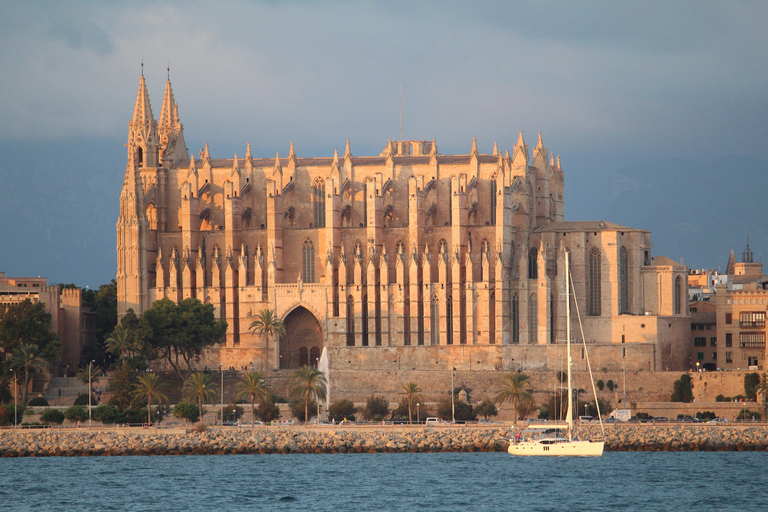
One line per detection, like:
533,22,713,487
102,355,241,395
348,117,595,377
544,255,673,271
0,452,768,512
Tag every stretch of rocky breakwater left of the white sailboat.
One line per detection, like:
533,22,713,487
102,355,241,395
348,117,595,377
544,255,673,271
0,427,507,457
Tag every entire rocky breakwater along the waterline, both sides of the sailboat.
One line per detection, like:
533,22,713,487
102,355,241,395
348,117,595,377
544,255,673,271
0,425,768,457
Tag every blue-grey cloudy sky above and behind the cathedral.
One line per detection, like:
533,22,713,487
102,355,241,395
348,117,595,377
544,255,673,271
0,0,768,287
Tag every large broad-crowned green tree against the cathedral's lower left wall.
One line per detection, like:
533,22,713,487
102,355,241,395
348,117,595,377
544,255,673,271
139,298,227,379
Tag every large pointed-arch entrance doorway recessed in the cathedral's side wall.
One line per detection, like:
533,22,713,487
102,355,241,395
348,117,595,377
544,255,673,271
280,306,323,370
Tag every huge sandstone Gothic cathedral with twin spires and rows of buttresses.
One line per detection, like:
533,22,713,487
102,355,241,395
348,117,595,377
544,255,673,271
117,74,690,371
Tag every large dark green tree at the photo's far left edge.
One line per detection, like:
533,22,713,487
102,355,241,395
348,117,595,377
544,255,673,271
0,299,61,362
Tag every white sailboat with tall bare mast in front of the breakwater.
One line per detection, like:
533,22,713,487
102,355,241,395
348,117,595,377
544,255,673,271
507,250,605,457
